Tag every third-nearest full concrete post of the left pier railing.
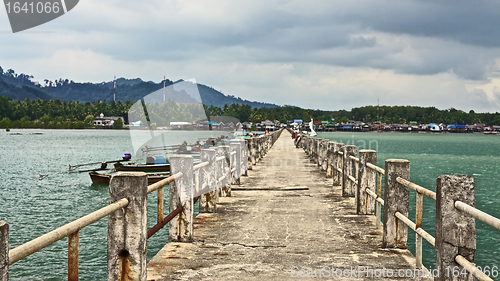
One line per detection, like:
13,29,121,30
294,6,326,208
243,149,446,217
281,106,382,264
200,149,217,213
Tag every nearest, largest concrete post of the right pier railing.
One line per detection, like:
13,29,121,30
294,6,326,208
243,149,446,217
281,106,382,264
434,175,476,280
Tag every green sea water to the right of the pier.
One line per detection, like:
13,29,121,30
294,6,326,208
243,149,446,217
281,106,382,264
318,132,500,268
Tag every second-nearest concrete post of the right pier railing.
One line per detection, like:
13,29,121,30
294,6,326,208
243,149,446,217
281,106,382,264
382,159,410,249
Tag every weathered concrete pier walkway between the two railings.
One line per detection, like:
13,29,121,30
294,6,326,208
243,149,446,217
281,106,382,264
147,130,424,280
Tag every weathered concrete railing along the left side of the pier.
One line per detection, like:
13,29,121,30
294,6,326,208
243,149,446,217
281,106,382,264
0,130,281,281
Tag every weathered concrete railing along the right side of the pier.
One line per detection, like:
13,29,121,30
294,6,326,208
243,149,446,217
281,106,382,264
301,133,500,280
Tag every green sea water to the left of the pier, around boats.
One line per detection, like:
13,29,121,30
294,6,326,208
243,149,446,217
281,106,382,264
0,129,219,280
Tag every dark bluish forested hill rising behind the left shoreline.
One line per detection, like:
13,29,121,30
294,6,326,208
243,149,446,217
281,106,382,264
0,67,279,108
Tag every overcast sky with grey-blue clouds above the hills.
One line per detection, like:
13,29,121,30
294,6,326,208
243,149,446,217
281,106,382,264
0,0,500,112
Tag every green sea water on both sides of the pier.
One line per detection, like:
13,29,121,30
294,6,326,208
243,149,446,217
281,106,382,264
0,130,500,280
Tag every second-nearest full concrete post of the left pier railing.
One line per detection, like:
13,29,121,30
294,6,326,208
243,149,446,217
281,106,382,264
168,155,194,242
